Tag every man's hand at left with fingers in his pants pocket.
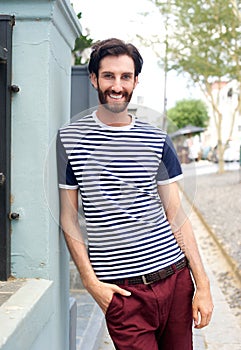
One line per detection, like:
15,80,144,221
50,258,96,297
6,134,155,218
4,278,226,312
87,281,131,314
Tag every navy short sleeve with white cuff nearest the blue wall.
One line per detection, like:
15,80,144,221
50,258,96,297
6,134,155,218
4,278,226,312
56,132,79,190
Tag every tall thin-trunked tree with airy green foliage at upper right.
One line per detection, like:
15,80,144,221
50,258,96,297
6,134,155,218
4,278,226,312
147,0,241,173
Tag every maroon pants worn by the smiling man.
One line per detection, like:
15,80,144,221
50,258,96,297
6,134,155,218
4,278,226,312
106,267,194,350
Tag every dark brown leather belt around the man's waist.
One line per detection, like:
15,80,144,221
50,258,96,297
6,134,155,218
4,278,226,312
106,258,187,285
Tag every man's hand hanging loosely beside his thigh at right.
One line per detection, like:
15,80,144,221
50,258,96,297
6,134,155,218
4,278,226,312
192,287,213,329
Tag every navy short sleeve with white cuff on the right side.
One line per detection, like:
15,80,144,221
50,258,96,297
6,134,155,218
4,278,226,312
157,135,183,185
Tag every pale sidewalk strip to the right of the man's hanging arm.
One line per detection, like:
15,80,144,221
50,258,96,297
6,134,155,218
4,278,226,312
183,194,241,350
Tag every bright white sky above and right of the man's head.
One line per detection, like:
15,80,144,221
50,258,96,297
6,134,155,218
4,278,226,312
70,0,201,112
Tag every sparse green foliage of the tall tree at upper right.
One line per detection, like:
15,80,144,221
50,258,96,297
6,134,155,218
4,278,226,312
157,0,241,81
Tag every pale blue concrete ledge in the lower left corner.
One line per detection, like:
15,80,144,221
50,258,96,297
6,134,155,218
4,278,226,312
0,279,54,350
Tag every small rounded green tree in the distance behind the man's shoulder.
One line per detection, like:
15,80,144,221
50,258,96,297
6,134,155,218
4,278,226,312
167,99,209,129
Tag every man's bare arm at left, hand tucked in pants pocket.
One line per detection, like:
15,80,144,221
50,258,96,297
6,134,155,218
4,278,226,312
60,189,130,313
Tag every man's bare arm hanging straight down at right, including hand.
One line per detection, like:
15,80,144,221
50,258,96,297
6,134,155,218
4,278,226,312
158,182,213,328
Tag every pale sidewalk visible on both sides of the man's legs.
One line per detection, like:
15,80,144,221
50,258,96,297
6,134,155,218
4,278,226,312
71,165,241,350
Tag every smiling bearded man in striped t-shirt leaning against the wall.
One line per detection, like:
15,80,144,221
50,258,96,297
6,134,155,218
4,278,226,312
58,39,213,350
